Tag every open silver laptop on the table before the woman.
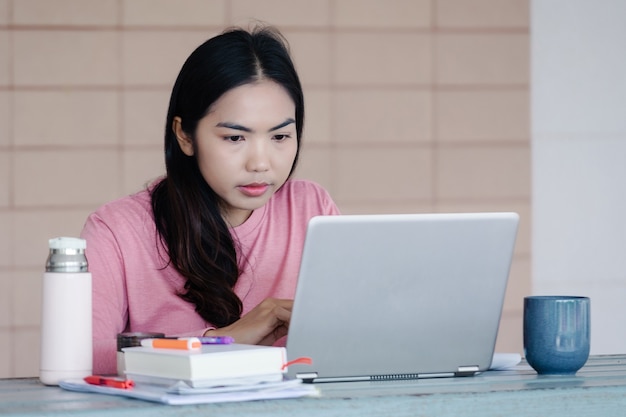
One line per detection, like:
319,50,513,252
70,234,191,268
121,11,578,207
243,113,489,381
287,213,519,382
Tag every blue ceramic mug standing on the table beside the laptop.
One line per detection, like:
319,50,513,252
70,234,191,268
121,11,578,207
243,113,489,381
524,295,590,375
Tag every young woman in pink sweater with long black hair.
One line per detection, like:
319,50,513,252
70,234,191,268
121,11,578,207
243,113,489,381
82,28,338,373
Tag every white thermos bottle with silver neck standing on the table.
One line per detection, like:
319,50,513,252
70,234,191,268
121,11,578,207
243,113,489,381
39,237,93,385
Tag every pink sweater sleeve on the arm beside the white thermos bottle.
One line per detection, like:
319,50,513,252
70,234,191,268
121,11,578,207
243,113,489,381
81,213,128,374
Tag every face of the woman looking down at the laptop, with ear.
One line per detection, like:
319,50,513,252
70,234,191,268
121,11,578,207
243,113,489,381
174,80,298,226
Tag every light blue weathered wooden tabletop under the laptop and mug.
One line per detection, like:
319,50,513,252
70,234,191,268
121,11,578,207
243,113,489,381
0,355,626,417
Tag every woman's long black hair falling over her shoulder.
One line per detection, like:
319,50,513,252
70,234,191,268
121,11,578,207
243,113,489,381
151,27,304,327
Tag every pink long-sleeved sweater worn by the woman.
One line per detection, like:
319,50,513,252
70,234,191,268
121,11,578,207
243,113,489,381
81,180,339,374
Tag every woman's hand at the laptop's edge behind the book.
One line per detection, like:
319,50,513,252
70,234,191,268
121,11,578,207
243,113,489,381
205,298,293,346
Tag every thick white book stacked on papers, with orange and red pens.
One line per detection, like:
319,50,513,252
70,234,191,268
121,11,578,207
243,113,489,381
59,338,318,404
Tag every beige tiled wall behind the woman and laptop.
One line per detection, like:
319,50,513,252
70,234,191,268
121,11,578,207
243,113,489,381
0,0,531,377
